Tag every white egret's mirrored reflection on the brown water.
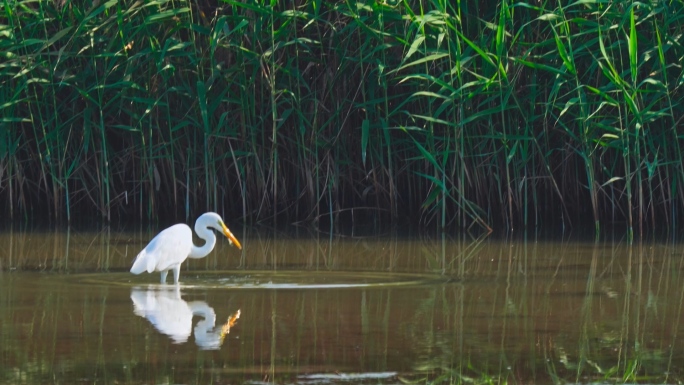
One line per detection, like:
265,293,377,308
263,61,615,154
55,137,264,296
131,286,240,350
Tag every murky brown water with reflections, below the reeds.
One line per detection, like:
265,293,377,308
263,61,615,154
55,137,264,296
0,226,684,384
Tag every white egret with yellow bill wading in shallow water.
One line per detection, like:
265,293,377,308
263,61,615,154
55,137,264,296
131,213,242,284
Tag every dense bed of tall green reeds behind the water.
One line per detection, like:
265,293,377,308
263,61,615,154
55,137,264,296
0,0,684,231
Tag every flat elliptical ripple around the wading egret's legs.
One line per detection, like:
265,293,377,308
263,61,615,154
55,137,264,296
71,271,450,289
